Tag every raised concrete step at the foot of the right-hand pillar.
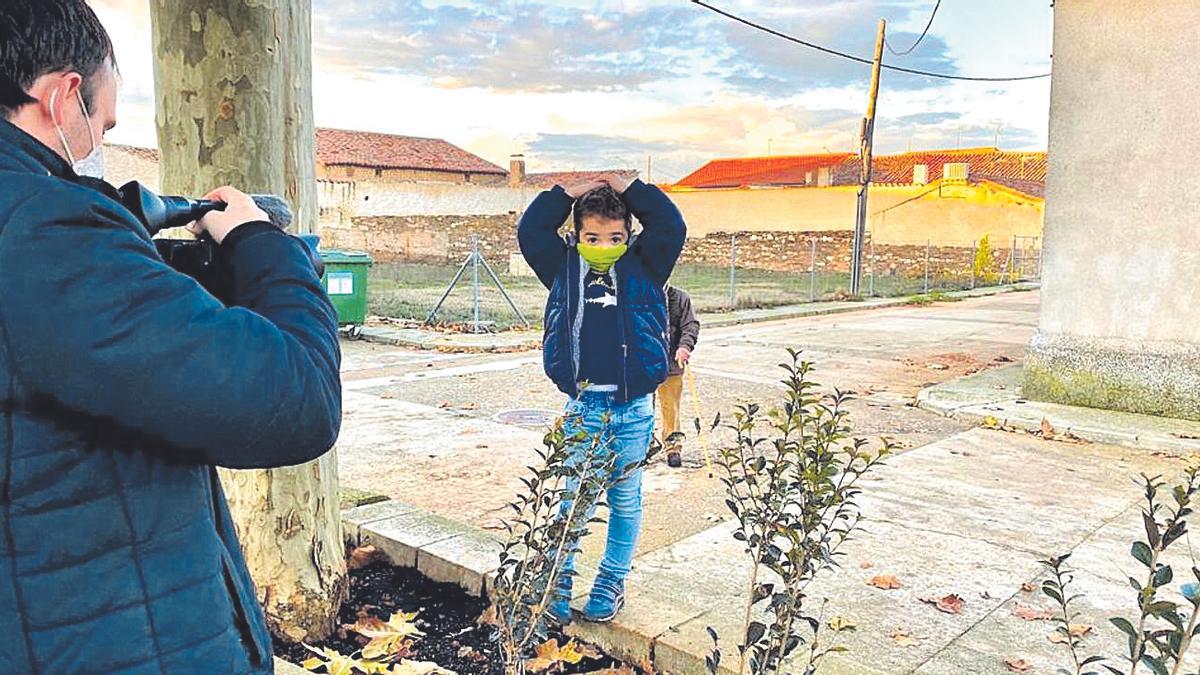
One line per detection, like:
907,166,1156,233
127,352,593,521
917,364,1200,454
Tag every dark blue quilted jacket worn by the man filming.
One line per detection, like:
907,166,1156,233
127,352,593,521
0,120,341,675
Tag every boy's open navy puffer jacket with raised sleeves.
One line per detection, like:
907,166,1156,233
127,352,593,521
517,180,688,402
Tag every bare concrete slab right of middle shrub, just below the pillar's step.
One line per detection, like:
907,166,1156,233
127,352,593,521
860,429,1176,557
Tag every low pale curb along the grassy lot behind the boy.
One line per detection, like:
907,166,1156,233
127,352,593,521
359,282,1040,353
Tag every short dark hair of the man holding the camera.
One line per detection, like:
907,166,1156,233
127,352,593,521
0,0,113,119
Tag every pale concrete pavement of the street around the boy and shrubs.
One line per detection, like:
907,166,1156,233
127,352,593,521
328,288,1189,673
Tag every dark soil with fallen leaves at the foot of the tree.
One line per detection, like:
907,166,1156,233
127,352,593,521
275,563,619,675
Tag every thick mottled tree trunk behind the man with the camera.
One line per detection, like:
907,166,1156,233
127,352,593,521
150,0,346,641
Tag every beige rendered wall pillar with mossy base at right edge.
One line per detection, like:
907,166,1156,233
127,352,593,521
1025,0,1200,419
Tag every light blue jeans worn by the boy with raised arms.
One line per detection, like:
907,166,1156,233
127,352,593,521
563,390,654,581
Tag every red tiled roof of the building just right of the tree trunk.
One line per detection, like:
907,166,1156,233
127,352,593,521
317,129,508,175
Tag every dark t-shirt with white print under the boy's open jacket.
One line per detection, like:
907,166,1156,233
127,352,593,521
580,270,623,384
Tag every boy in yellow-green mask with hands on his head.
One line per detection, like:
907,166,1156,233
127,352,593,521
517,175,686,623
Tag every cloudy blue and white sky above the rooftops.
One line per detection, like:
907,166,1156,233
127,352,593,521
92,0,1052,181
